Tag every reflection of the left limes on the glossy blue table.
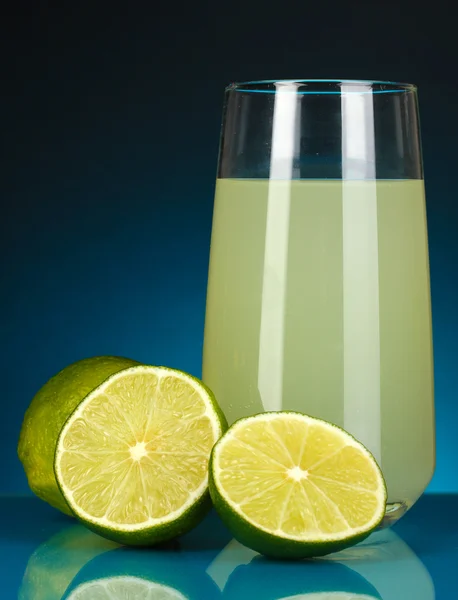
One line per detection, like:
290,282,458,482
19,525,221,600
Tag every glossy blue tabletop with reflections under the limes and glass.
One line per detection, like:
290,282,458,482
0,495,458,600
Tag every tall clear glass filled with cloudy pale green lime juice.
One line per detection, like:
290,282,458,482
203,80,435,524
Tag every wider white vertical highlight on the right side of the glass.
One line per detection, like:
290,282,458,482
341,85,381,465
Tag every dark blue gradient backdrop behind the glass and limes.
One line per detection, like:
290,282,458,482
0,0,458,493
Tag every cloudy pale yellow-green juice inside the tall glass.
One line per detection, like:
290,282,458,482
203,179,435,517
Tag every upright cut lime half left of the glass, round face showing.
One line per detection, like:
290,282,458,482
54,365,226,545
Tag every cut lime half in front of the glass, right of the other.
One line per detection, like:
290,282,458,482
210,412,386,558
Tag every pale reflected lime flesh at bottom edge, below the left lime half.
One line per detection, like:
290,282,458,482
69,576,186,600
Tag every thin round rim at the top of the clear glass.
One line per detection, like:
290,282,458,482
226,79,417,95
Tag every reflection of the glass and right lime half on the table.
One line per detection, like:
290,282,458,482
207,530,435,600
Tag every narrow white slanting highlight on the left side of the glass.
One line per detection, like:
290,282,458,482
258,83,300,410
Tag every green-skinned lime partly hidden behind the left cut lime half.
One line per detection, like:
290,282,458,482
18,356,138,514
